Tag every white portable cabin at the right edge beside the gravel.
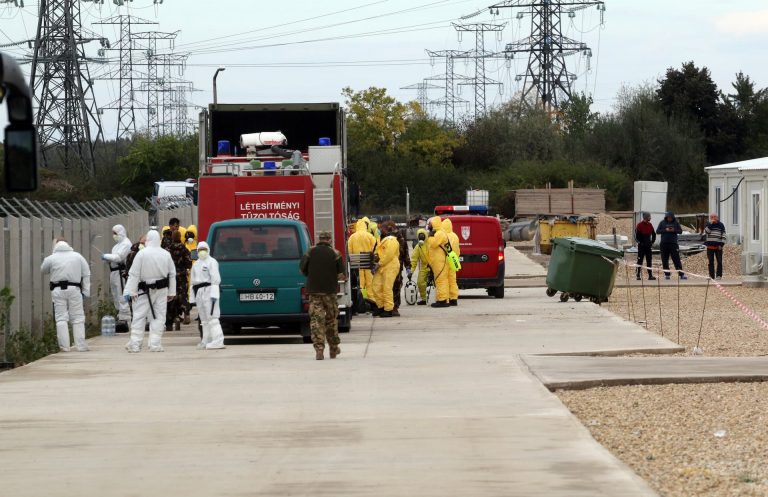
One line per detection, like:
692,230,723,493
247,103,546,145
706,157,768,286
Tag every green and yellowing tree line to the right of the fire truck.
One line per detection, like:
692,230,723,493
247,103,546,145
344,62,768,215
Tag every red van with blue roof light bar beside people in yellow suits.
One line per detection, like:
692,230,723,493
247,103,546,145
435,206,506,299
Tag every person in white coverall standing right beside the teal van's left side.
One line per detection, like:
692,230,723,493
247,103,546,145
189,242,225,349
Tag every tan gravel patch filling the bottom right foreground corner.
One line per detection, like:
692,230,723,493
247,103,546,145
557,383,768,497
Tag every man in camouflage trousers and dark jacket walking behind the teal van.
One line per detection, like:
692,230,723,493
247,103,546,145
299,231,346,361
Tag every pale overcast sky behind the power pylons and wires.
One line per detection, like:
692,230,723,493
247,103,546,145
0,0,768,137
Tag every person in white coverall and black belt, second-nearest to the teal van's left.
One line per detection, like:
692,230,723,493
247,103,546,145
123,230,176,352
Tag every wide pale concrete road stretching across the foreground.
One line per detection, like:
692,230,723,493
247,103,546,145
0,289,675,497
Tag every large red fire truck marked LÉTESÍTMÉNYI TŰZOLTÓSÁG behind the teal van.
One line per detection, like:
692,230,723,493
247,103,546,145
198,103,352,331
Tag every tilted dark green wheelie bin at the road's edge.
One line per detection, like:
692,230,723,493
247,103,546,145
547,237,624,304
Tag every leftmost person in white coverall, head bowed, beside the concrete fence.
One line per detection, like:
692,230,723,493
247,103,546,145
40,240,91,352
